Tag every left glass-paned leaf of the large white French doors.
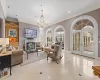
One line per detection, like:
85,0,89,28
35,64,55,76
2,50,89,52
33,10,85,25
72,30,81,55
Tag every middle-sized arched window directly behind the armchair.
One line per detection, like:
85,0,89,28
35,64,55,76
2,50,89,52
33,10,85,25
54,25,65,49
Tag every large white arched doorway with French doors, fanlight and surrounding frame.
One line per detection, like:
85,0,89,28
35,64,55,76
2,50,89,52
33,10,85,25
70,15,98,58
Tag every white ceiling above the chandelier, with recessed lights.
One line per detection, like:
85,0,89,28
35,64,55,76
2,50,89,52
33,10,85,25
6,0,100,25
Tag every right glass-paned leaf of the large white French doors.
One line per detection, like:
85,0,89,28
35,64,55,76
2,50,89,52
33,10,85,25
82,30,94,58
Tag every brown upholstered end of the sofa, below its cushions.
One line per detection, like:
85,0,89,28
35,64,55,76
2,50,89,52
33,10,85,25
11,50,23,66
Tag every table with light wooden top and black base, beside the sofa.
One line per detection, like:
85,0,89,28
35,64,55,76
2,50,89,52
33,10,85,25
0,51,12,75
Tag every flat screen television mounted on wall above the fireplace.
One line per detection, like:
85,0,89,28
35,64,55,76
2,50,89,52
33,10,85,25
24,29,37,38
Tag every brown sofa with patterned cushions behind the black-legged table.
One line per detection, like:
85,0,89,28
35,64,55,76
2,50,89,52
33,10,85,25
0,45,23,66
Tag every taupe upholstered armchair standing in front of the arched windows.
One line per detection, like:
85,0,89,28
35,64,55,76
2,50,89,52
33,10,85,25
47,44,62,64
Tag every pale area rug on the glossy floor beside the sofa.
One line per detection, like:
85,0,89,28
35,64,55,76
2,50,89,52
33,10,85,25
21,51,47,66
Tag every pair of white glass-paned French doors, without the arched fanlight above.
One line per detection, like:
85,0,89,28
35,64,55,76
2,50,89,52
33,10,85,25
72,30,95,58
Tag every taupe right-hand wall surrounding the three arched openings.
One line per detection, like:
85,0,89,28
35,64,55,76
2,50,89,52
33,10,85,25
43,9,100,53
